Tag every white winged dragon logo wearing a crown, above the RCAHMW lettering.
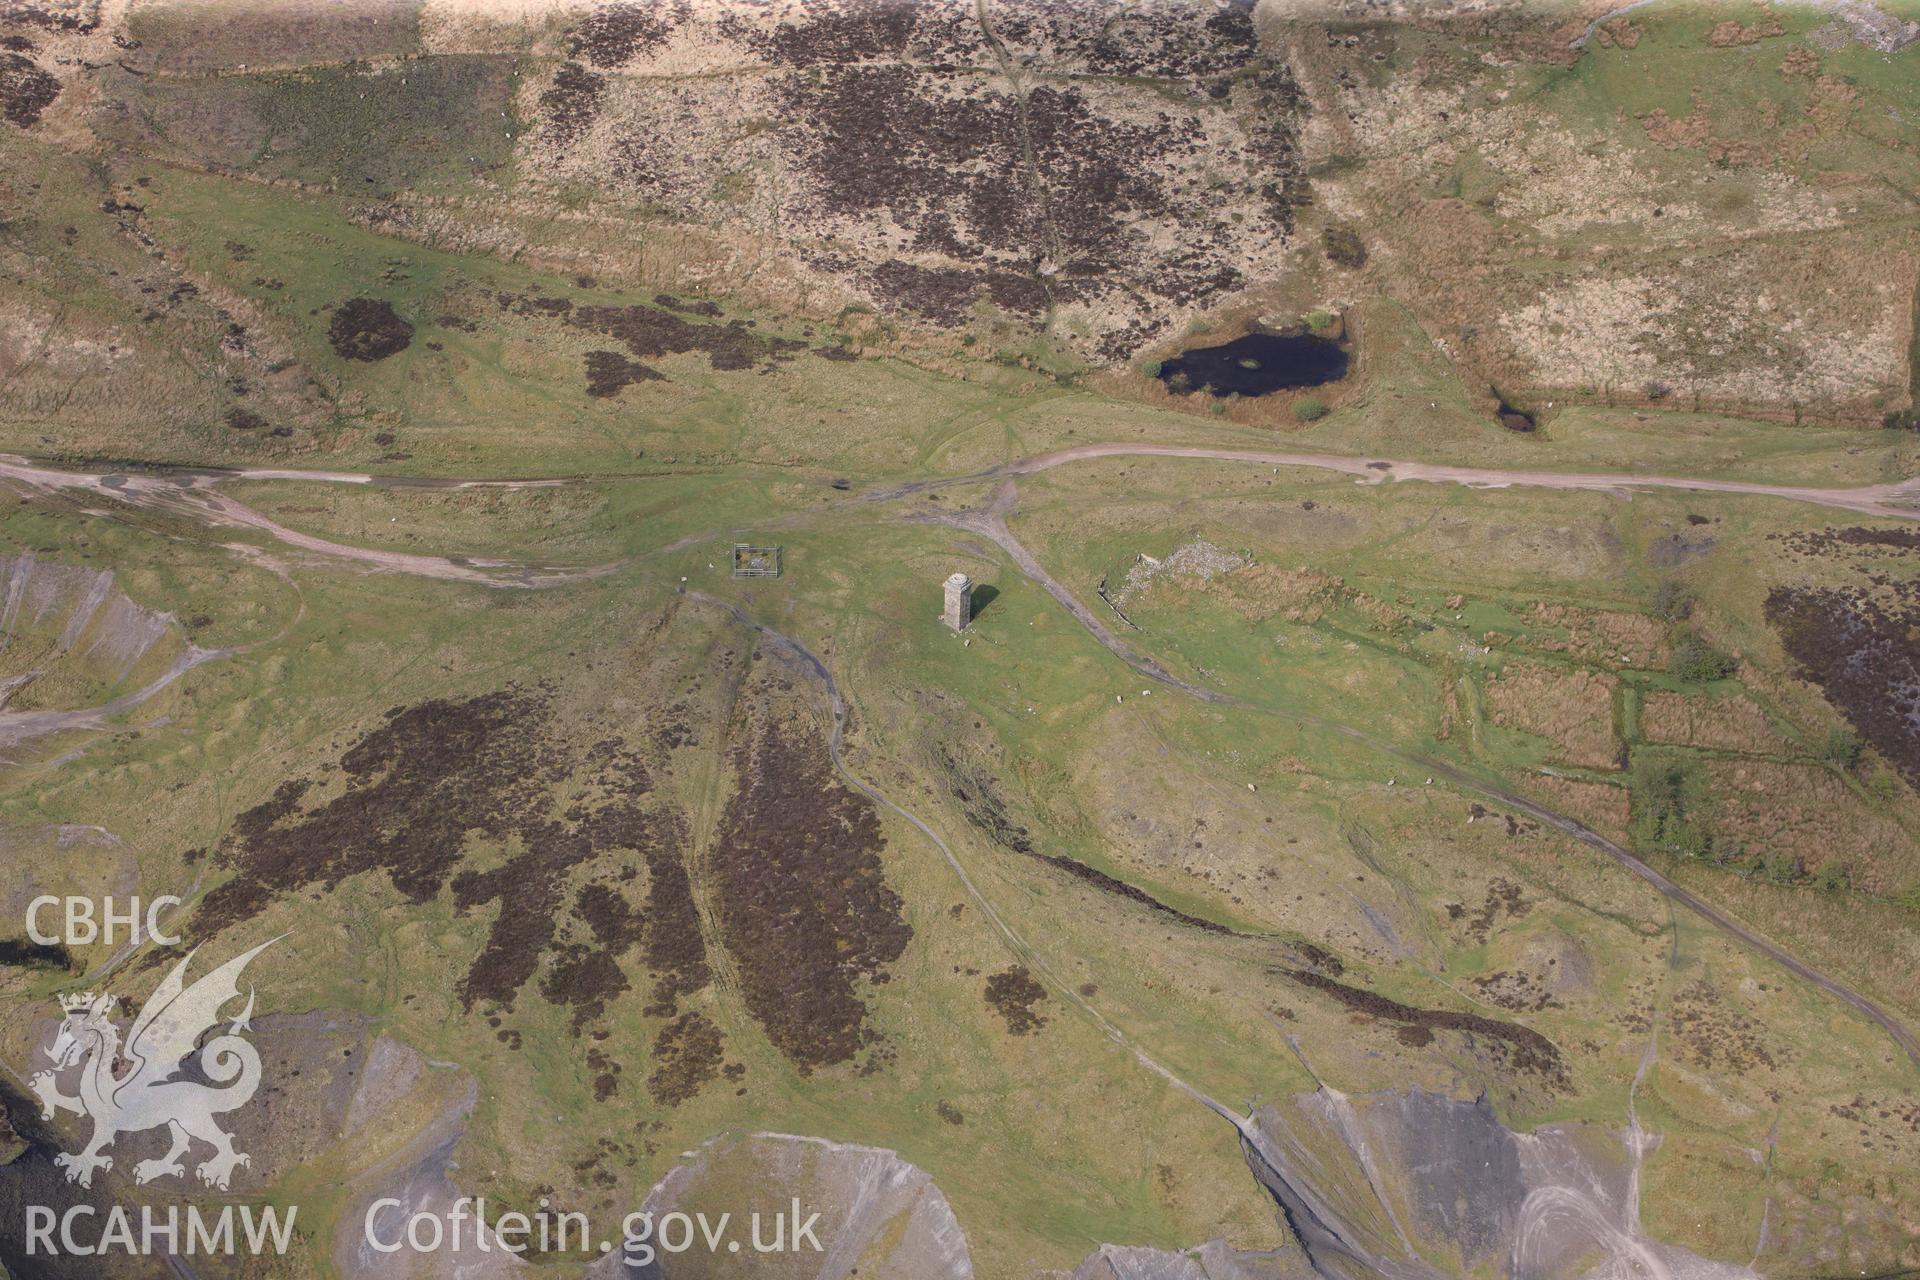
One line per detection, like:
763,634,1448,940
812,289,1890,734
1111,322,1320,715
31,938,278,1190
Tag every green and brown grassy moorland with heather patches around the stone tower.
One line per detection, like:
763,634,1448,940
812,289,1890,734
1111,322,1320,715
0,4,1920,1276
